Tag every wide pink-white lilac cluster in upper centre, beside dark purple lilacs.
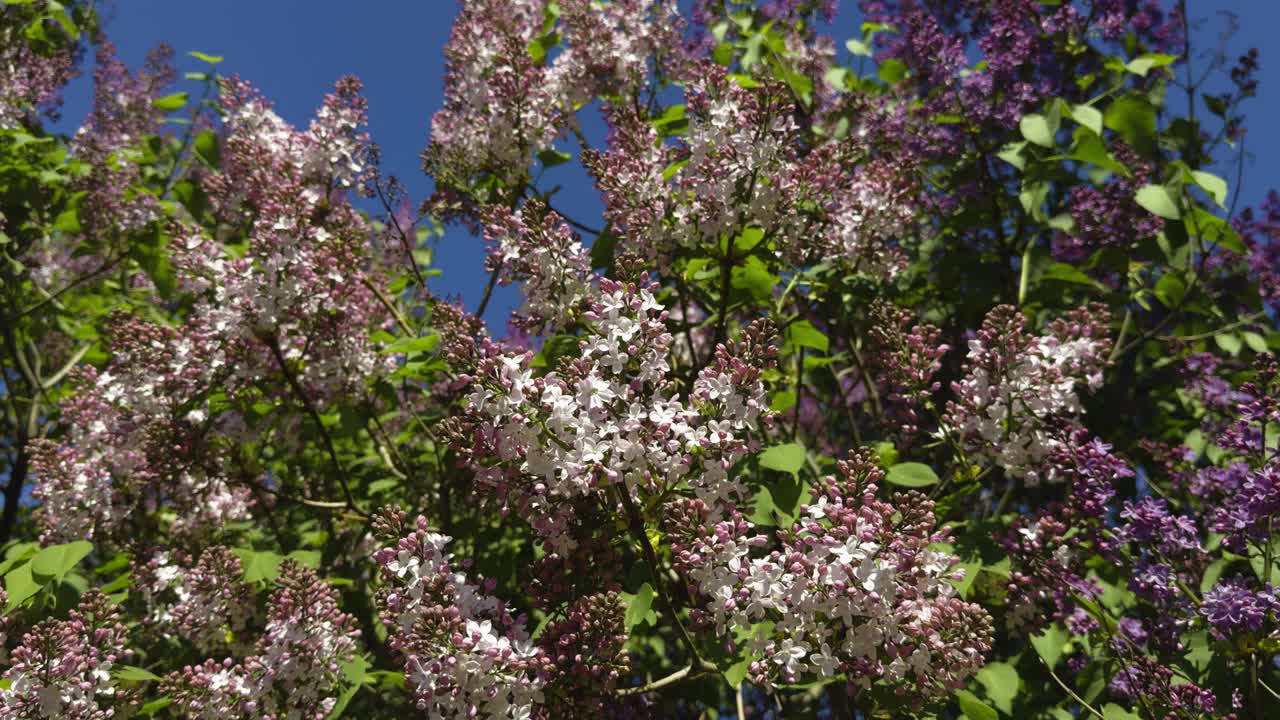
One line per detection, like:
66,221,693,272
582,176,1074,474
584,64,914,275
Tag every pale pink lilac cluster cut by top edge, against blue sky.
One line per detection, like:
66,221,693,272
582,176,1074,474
424,0,680,197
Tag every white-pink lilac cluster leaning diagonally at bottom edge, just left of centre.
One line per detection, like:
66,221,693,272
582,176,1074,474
374,518,549,720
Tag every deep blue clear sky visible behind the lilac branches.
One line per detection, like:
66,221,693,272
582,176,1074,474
64,0,1280,325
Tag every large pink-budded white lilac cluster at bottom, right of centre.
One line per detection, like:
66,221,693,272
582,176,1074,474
667,454,992,700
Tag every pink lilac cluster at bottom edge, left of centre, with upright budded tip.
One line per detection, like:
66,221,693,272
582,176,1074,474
164,560,360,720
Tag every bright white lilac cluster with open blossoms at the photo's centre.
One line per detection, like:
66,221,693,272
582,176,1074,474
454,271,773,552
